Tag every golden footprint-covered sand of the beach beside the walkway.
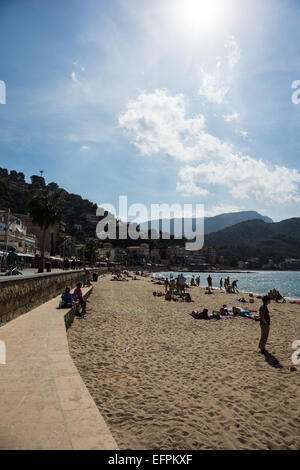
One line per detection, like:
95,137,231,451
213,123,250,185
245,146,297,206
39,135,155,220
68,276,300,450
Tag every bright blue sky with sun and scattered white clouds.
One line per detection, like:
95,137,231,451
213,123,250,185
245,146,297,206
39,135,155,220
0,0,300,220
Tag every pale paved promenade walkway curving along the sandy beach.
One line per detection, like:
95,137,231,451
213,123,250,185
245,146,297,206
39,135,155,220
0,289,117,450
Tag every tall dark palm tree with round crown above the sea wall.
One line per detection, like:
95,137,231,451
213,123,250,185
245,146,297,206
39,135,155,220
28,190,62,273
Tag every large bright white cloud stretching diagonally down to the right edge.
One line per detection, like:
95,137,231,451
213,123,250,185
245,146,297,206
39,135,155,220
119,90,300,203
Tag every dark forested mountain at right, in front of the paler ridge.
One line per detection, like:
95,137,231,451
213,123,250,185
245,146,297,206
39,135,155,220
205,218,300,261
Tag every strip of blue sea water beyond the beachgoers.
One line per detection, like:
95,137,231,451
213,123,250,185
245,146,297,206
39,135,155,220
155,271,300,300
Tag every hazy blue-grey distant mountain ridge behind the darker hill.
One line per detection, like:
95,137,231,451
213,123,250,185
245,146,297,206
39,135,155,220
140,211,273,235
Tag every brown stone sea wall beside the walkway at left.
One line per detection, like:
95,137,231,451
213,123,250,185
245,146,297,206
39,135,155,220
0,270,83,327
